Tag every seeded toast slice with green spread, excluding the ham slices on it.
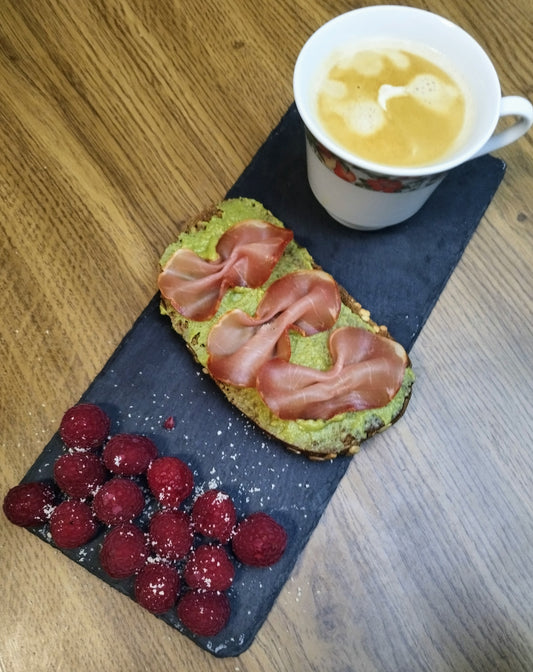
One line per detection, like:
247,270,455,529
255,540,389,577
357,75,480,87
156,198,414,460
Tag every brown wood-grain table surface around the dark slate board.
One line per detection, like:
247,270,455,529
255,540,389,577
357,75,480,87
0,0,533,672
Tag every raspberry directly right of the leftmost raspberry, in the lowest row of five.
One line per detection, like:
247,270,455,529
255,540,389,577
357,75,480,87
50,499,98,548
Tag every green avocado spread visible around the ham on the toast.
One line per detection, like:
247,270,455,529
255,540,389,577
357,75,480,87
160,198,414,457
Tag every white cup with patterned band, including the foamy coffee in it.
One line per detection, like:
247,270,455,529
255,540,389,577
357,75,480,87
293,5,533,230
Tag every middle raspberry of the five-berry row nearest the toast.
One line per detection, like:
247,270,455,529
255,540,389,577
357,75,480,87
146,457,194,509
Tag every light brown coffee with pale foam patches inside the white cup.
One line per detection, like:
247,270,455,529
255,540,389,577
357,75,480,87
316,44,467,167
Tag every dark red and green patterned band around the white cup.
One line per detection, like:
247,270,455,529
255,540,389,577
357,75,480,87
305,129,443,194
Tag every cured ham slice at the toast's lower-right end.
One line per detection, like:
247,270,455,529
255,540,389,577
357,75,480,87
256,327,408,420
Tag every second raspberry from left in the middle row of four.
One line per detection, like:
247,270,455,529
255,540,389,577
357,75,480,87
93,476,144,525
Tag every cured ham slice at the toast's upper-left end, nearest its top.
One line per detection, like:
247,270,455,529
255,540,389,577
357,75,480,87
158,219,293,321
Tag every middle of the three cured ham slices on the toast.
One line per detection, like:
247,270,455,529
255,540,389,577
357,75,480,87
207,271,341,387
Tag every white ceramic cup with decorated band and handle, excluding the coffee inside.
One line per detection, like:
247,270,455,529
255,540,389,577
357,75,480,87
293,5,533,230
